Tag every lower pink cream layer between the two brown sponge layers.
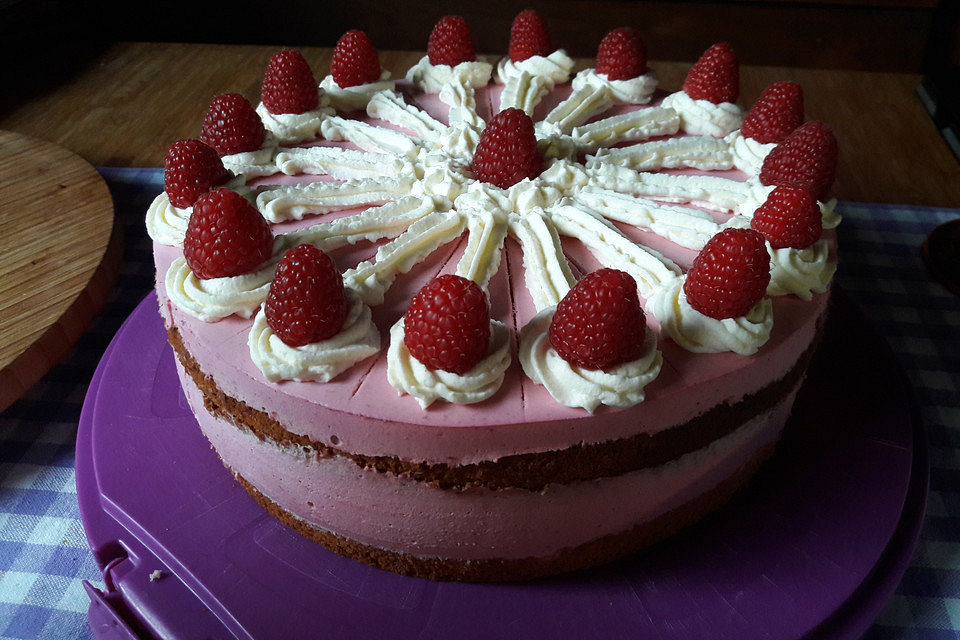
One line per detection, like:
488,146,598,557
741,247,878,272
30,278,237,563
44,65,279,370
184,365,796,560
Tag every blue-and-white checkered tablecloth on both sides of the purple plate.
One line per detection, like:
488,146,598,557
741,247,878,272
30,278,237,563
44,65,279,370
0,169,960,640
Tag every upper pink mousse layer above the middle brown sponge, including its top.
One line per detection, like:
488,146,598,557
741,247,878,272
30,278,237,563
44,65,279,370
154,87,835,465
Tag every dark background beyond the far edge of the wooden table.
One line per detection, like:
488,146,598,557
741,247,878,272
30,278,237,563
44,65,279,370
0,0,960,146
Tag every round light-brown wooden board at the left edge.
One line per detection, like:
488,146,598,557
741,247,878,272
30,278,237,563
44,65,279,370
0,131,121,411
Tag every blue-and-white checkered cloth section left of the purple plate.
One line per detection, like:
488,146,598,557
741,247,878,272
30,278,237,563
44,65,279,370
0,169,163,640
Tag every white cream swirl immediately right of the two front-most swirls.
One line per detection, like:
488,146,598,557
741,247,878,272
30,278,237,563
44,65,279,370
647,278,773,356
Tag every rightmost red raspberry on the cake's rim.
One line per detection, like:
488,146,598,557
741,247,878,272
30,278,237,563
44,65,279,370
760,120,837,200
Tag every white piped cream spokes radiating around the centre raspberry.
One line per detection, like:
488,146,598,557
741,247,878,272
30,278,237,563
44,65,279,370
149,69,839,390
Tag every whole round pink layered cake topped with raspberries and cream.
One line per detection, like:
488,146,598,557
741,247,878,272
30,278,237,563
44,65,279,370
147,12,839,581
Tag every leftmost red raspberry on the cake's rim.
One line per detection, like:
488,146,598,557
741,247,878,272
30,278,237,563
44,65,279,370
163,138,231,209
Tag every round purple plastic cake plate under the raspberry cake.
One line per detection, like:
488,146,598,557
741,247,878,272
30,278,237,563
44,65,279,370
77,291,928,640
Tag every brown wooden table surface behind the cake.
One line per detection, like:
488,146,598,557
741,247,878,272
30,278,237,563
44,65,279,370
0,43,960,207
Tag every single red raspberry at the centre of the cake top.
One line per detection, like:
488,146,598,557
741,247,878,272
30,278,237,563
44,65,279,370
471,109,543,189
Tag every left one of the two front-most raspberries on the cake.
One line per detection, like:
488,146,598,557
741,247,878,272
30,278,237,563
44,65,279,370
403,274,490,374
